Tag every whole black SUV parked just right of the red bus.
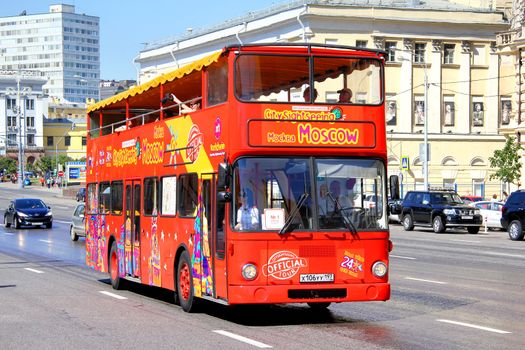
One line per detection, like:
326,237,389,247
401,190,483,234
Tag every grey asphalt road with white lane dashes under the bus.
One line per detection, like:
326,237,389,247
0,184,525,350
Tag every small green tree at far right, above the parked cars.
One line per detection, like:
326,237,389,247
489,137,523,191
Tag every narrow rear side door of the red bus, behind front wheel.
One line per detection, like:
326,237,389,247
124,180,141,277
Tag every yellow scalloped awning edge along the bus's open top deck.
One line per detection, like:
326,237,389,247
87,51,223,113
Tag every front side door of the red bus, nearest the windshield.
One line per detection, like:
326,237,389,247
200,174,227,300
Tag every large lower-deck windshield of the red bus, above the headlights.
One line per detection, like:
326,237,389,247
233,157,387,232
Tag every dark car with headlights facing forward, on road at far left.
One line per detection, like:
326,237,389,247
4,198,53,228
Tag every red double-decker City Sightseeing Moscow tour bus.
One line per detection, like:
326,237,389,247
86,44,398,311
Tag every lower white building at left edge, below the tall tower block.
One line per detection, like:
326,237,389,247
0,70,48,164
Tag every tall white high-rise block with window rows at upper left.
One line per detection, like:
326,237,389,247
0,5,100,102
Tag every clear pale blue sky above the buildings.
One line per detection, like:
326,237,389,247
0,0,280,80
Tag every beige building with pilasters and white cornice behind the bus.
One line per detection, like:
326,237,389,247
136,0,514,197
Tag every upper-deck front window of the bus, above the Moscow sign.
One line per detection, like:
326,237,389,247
235,54,382,105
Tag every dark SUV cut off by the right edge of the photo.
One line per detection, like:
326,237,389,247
501,190,525,241
